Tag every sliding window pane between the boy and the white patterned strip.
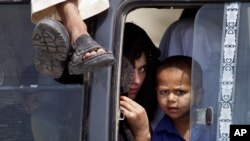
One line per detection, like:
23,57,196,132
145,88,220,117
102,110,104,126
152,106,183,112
191,5,224,141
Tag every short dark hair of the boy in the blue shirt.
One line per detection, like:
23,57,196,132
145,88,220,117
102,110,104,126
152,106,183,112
156,55,203,89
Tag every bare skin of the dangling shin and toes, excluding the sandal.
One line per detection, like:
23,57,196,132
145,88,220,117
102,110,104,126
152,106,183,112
57,0,105,59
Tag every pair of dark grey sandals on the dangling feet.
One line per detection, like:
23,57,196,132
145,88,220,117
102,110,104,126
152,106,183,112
32,18,114,78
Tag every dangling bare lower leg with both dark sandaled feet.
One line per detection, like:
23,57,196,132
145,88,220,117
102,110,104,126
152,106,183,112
32,0,115,78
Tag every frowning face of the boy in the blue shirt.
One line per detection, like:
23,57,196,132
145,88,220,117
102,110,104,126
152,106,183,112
156,67,191,120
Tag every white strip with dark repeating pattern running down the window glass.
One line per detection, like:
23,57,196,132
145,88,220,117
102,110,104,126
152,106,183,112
218,3,240,141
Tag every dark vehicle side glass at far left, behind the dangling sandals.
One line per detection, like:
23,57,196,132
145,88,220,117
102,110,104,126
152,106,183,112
0,5,83,141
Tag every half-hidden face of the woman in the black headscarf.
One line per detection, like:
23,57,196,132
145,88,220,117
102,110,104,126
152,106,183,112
128,53,147,99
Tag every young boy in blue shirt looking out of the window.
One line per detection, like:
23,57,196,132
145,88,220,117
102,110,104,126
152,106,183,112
152,56,203,141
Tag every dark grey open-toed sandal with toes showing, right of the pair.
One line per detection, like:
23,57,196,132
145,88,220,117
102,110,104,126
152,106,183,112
68,34,114,74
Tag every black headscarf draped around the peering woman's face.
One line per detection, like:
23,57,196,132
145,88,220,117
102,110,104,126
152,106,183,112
123,23,160,121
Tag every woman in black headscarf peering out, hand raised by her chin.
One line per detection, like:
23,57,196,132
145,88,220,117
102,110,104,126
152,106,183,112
119,23,160,141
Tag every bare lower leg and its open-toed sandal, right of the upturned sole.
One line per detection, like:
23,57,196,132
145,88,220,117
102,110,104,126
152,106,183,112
56,0,114,74
